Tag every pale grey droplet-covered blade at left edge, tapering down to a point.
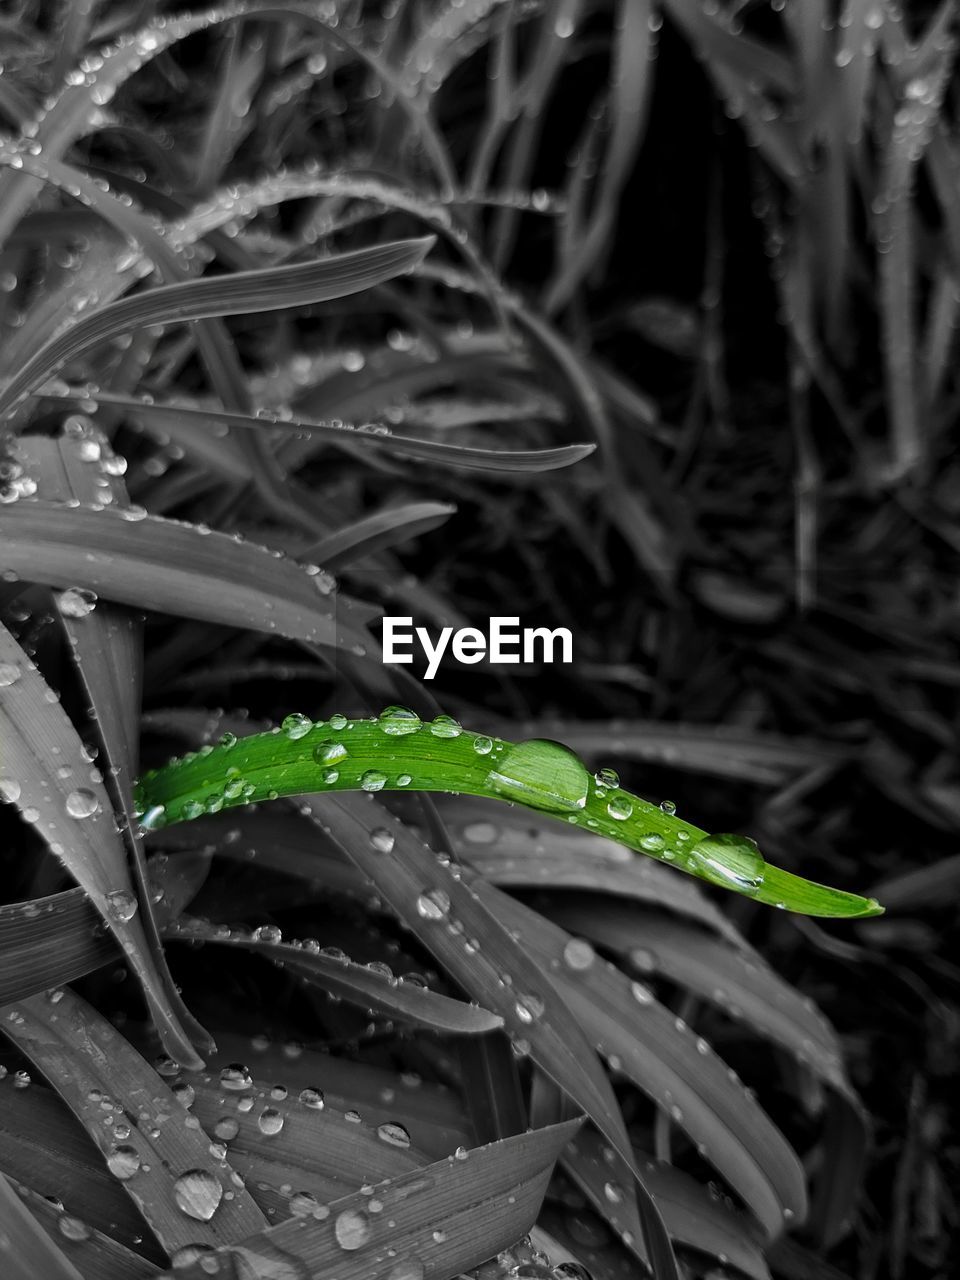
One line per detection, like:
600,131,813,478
0,623,200,1065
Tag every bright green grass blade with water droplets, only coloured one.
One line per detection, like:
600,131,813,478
137,708,882,918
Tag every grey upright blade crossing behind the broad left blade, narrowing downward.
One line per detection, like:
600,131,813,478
18,430,212,1050
